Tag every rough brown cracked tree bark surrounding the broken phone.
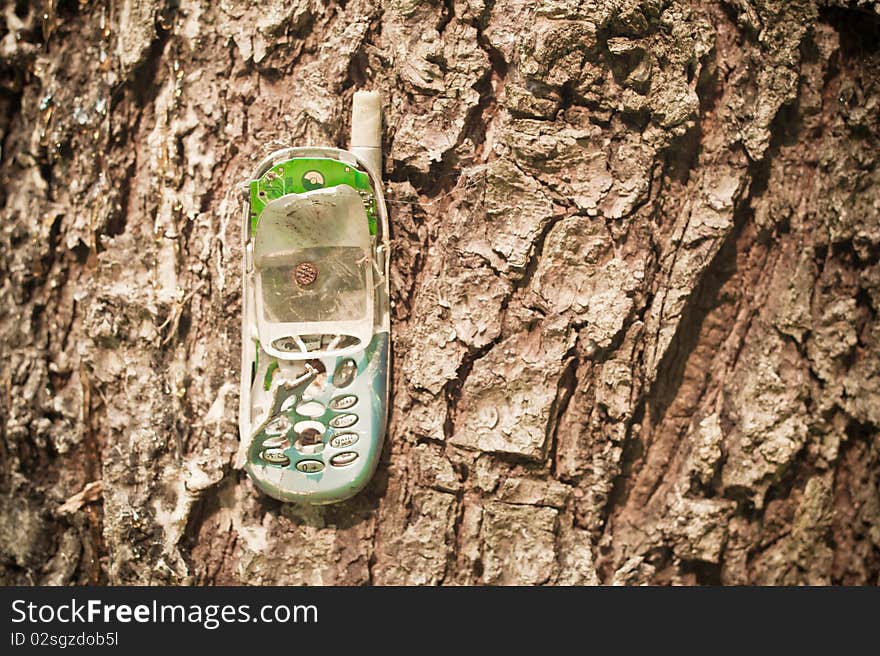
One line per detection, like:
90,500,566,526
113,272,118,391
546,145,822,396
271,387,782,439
0,0,880,584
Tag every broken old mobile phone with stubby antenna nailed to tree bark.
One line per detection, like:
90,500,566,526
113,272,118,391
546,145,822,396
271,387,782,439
239,91,389,504
